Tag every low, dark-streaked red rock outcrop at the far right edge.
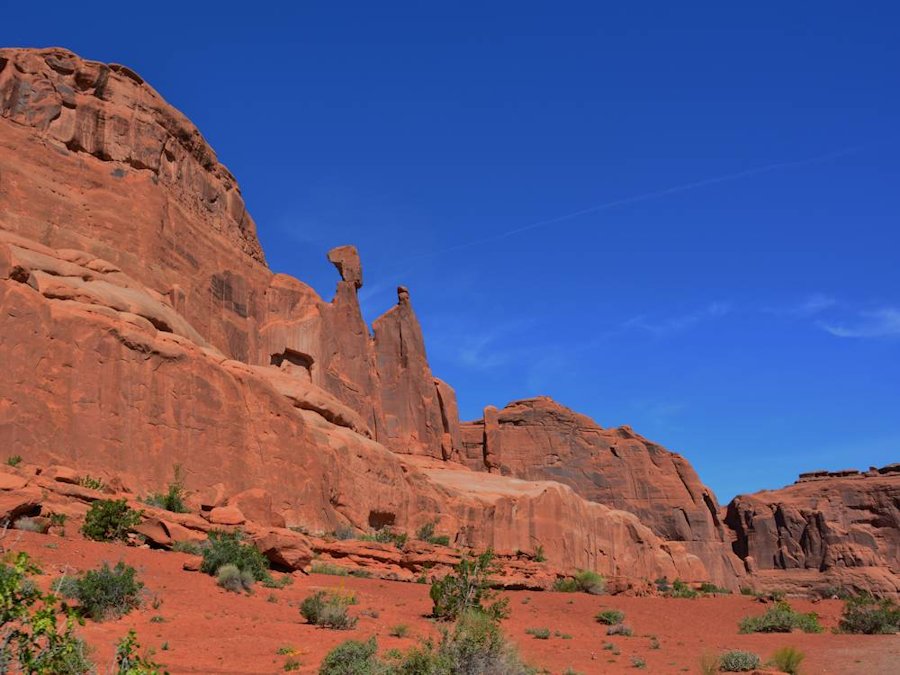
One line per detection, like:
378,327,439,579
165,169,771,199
725,467,900,594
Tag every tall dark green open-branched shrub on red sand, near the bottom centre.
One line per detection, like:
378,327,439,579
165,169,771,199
430,550,509,620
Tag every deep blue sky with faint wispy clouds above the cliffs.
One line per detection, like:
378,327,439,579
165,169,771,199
0,2,900,501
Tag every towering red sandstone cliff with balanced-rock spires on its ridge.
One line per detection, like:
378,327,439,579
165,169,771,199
0,49,897,590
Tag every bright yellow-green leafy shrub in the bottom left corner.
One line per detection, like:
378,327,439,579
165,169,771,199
0,553,94,675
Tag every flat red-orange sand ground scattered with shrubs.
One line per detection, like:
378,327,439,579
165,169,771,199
2,532,900,675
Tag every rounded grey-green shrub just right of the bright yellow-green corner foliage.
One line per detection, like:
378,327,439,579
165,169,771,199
56,560,144,621
